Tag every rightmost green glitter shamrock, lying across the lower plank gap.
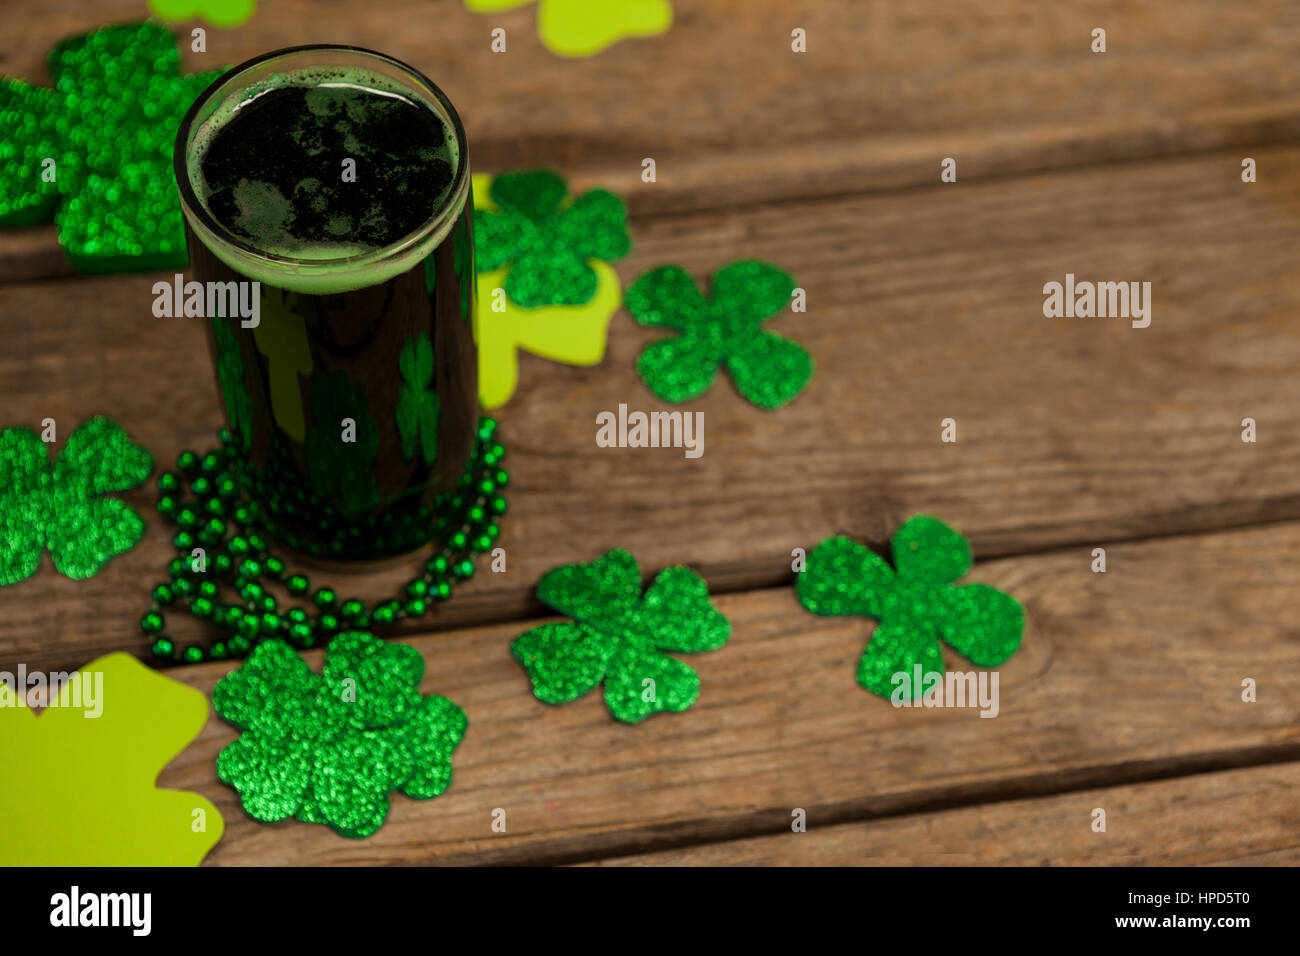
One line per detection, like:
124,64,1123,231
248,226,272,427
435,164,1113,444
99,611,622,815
794,515,1024,700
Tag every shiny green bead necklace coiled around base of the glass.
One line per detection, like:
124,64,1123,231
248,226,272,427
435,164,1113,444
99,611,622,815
140,418,510,663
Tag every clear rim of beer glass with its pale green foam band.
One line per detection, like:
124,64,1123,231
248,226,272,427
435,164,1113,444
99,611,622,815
172,43,469,293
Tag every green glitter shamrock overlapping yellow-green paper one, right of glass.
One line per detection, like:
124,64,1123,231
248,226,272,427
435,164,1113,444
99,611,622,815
475,169,632,308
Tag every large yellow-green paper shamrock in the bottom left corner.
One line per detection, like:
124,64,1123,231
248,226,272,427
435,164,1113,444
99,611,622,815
0,654,224,866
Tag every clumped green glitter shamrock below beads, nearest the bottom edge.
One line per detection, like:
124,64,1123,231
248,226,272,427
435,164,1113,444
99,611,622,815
212,631,468,838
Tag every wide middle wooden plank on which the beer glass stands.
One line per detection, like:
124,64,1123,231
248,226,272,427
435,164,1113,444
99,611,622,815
0,150,1300,666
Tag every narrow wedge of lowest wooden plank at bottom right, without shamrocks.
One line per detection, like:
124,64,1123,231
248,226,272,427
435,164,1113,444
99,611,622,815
589,763,1300,866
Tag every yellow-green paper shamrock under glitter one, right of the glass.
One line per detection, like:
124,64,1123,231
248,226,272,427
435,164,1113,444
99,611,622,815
473,176,623,408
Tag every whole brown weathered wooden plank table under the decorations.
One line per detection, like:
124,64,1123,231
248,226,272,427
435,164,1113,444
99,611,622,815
0,0,1300,865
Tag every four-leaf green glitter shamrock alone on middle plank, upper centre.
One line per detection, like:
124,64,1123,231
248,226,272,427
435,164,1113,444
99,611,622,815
624,261,813,408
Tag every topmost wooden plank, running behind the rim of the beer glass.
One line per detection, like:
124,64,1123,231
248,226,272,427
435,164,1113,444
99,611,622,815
0,0,1300,280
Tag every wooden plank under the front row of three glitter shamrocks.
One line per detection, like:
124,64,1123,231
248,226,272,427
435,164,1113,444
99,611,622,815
134,523,1300,865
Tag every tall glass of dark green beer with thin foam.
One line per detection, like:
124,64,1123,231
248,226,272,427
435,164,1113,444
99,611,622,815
176,46,478,566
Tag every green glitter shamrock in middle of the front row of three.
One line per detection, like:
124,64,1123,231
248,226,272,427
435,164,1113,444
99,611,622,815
510,550,731,723
